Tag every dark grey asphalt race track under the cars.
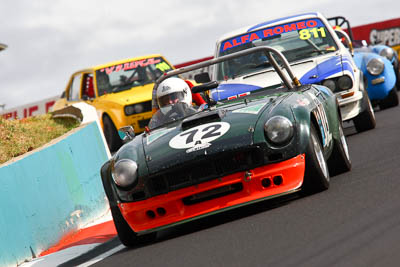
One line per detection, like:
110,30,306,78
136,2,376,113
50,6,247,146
63,100,400,267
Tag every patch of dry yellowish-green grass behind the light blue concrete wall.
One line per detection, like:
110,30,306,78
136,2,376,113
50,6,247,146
0,113,79,164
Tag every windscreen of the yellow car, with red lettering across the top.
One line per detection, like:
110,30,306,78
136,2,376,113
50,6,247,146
96,57,172,96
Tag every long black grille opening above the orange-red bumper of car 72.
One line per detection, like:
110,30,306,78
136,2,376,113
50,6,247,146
147,148,264,196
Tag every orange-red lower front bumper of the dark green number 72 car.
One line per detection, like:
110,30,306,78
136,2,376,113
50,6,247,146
118,154,305,234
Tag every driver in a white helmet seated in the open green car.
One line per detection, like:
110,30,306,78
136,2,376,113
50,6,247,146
149,77,196,129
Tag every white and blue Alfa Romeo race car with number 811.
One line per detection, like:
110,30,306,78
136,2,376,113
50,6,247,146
210,12,375,132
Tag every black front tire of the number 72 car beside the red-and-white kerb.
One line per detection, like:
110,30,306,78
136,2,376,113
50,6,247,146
110,205,157,247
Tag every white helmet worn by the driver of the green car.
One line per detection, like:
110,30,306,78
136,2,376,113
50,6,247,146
157,77,192,114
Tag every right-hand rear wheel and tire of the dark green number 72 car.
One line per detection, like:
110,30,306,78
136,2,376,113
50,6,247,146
328,118,351,176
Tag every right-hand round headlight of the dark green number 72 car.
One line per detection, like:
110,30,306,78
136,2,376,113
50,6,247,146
264,116,294,145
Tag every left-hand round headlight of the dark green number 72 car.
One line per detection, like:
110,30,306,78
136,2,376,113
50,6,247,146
112,159,138,187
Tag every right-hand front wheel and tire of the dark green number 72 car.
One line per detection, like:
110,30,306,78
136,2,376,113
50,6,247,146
302,123,330,195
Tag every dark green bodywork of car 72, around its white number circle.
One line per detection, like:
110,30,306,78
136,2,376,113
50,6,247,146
103,82,340,204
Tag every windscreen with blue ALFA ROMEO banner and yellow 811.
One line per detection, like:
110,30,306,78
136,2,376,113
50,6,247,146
216,18,338,81
